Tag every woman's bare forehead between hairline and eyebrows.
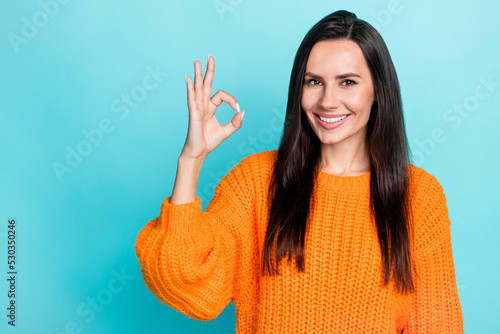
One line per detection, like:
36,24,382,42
306,40,369,73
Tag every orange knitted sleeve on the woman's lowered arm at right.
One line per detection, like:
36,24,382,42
404,174,464,334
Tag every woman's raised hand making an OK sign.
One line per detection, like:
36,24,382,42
181,56,244,159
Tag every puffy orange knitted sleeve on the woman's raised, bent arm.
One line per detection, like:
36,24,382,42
135,157,253,320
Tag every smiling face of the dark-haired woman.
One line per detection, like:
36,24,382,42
301,40,375,149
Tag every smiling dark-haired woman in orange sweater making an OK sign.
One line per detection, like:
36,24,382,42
136,11,463,333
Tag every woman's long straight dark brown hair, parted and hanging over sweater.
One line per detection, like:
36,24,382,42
262,10,415,293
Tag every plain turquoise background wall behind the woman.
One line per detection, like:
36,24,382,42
0,0,500,334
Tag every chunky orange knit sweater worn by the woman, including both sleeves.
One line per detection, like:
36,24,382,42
135,150,463,334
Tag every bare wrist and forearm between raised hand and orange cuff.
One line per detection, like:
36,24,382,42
170,154,204,205
